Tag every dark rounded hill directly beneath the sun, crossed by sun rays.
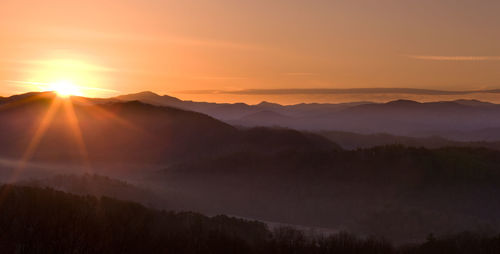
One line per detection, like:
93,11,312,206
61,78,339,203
0,93,336,164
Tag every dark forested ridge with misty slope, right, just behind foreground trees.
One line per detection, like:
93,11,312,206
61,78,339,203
157,145,500,242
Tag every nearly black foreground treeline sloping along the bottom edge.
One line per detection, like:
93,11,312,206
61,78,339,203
0,185,500,254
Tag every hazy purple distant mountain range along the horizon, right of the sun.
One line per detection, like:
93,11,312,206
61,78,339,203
114,92,500,141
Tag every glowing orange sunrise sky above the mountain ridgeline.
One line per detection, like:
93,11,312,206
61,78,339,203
0,0,500,102
